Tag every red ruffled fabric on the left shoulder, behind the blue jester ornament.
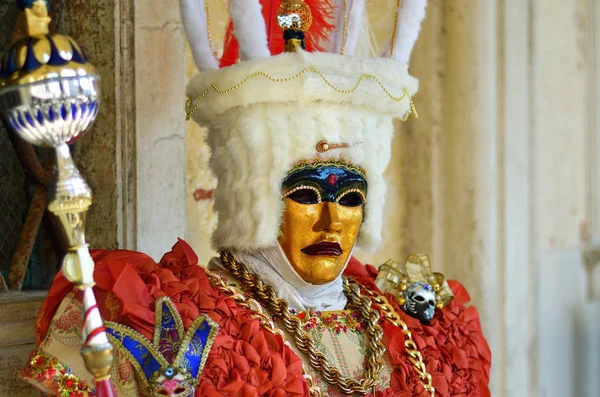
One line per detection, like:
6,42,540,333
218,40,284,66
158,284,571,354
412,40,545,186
36,240,309,397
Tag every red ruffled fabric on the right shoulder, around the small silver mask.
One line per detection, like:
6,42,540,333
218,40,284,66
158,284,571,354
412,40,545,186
344,258,492,397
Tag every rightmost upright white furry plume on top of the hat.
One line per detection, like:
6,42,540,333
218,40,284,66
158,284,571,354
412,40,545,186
388,0,427,63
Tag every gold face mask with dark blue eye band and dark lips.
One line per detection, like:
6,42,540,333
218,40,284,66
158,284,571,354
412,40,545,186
279,164,367,284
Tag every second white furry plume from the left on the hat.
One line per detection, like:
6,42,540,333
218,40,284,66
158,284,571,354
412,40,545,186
229,0,271,61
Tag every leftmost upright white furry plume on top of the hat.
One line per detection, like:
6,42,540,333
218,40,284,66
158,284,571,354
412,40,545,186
179,0,219,71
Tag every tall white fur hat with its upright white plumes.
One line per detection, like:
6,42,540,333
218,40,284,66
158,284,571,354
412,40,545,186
181,0,426,250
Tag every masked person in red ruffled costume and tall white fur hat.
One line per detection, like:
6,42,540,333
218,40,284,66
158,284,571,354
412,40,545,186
16,0,491,397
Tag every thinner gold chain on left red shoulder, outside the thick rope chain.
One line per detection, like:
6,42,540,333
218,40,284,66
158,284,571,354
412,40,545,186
205,269,323,397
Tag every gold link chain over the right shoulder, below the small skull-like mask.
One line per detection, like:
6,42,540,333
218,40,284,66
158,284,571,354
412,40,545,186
353,281,435,397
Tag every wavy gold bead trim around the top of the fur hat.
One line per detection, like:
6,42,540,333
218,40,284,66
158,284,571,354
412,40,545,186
185,67,419,121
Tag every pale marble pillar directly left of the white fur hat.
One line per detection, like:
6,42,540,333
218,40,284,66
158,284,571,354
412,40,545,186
129,0,186,260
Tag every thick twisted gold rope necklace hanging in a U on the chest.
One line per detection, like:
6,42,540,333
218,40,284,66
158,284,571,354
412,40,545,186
221,252,385,395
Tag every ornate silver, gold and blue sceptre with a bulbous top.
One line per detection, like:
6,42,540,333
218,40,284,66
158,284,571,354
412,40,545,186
0,0,116,397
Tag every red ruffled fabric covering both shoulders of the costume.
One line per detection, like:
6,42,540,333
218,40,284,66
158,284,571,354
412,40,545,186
36,240,491,397
